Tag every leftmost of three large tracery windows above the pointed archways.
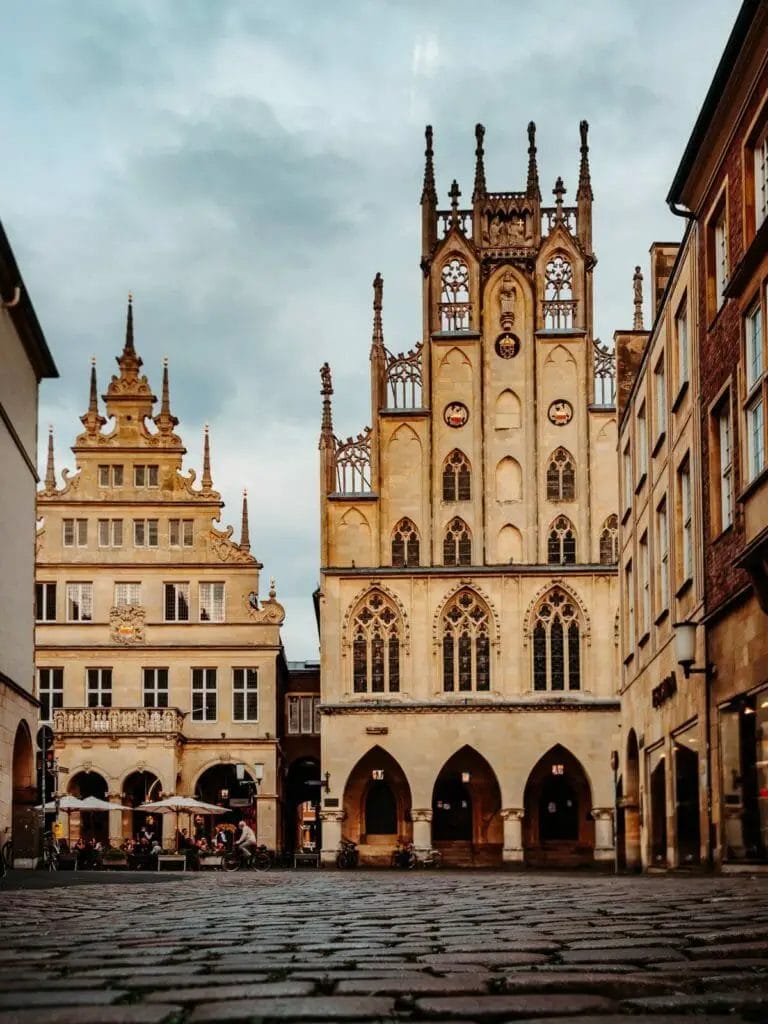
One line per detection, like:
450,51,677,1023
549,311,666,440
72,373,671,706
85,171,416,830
352,590,401,693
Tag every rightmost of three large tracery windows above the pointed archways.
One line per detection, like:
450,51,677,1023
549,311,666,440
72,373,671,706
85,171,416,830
532,587,582,690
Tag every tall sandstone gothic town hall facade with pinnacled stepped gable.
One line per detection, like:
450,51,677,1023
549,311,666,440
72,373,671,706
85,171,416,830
318,122,620,866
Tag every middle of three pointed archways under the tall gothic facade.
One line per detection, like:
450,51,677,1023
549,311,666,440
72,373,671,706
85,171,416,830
432,746,504,866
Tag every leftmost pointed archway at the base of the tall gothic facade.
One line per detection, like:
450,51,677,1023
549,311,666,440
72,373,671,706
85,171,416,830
343,745,412,863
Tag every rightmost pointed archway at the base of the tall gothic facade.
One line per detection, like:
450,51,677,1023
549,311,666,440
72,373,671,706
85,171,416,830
523,743,595,867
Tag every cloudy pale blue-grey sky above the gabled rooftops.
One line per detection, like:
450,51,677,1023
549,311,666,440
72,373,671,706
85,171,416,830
0,0,738,659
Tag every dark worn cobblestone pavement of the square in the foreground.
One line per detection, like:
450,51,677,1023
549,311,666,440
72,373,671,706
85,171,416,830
0,871,768,1024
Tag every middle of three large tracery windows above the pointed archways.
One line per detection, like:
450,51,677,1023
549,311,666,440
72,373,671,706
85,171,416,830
442,589,490,692
